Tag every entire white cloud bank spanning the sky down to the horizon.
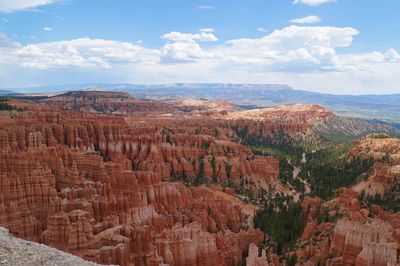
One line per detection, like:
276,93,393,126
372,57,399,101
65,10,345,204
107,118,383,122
0,25,400,93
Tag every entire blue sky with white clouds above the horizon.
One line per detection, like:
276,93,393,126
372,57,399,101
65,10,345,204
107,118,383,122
0,0,400,94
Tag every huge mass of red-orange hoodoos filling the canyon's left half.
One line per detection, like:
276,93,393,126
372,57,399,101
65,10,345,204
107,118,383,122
0,107,272,265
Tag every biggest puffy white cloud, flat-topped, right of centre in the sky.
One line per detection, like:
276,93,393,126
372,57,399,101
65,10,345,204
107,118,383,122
222,25,358,68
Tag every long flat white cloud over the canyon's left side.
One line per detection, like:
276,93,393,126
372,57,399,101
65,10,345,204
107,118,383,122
13,38,159,69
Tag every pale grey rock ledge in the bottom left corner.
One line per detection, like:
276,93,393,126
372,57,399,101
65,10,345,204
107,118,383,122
0,227,98,266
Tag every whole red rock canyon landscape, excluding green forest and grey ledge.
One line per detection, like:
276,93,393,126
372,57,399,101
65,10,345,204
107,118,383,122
0,91,400,266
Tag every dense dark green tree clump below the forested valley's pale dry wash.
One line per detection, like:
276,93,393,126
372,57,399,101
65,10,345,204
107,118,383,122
253,195,305,254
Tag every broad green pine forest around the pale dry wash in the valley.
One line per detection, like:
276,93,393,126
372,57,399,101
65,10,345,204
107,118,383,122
238,127,378,199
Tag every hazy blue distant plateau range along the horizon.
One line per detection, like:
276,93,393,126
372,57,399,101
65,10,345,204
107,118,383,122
0,83,400,122
